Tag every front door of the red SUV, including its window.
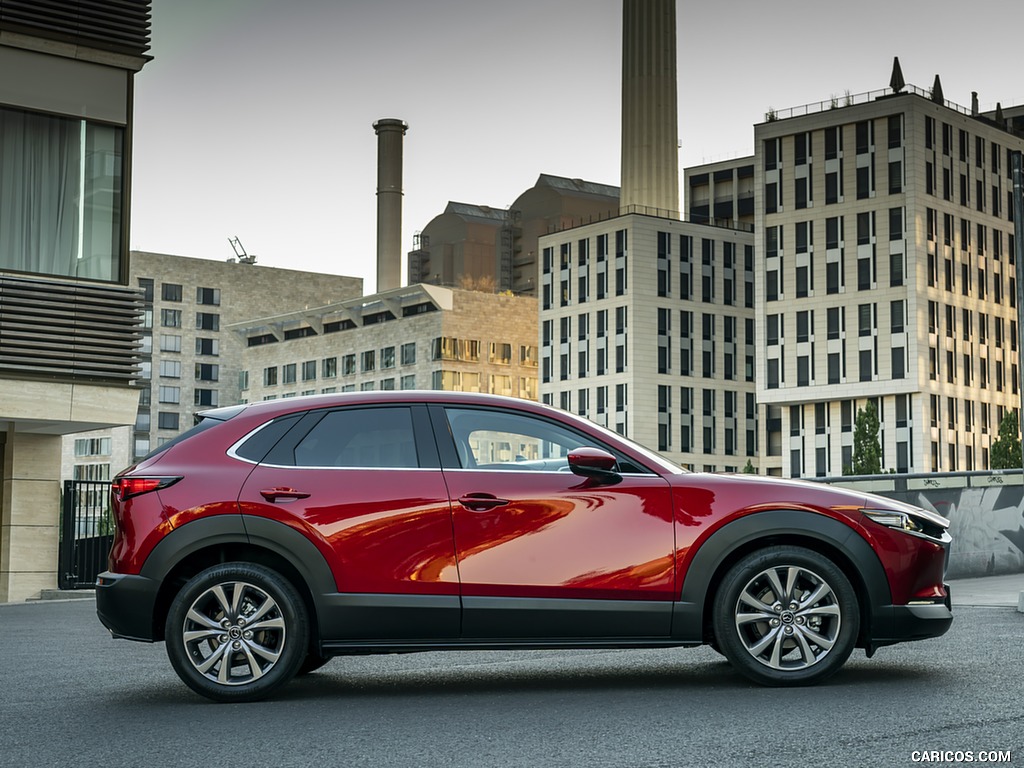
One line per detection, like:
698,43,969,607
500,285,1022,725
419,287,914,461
431,406,674,641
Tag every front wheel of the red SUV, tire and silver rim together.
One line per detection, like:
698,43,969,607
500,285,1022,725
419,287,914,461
713,546,860,686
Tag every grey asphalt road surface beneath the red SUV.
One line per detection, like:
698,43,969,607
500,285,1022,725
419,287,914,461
0,600,1024,768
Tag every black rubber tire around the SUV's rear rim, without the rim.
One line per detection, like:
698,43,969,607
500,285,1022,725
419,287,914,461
164,562,309,701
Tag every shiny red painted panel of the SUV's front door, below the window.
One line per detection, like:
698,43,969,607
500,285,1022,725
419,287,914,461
444,470,674,600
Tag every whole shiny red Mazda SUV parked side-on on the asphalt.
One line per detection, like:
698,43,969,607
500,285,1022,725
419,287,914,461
96,392,952,701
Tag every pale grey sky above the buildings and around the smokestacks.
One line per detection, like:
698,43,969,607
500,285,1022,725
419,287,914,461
131,0,1024,294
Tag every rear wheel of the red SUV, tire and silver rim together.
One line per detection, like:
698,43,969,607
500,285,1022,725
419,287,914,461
165,562,309,701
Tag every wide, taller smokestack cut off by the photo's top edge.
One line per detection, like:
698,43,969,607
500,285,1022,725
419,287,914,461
620,0,679,217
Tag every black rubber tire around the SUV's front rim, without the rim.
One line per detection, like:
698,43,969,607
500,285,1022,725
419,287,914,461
713,546,860,686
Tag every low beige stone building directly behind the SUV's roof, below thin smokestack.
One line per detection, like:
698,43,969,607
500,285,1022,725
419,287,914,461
229,285,538,401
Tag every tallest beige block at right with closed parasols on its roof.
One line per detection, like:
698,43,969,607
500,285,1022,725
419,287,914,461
755,86,1024,476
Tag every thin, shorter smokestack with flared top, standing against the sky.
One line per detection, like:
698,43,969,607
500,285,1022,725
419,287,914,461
374,118,409,292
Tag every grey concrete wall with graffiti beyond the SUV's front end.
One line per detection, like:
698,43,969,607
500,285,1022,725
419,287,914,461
825,469,1024,579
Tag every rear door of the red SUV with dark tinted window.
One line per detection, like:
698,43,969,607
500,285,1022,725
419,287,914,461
240,404,460,640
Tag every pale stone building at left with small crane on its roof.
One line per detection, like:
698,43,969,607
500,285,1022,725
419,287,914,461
62,251,362,480
